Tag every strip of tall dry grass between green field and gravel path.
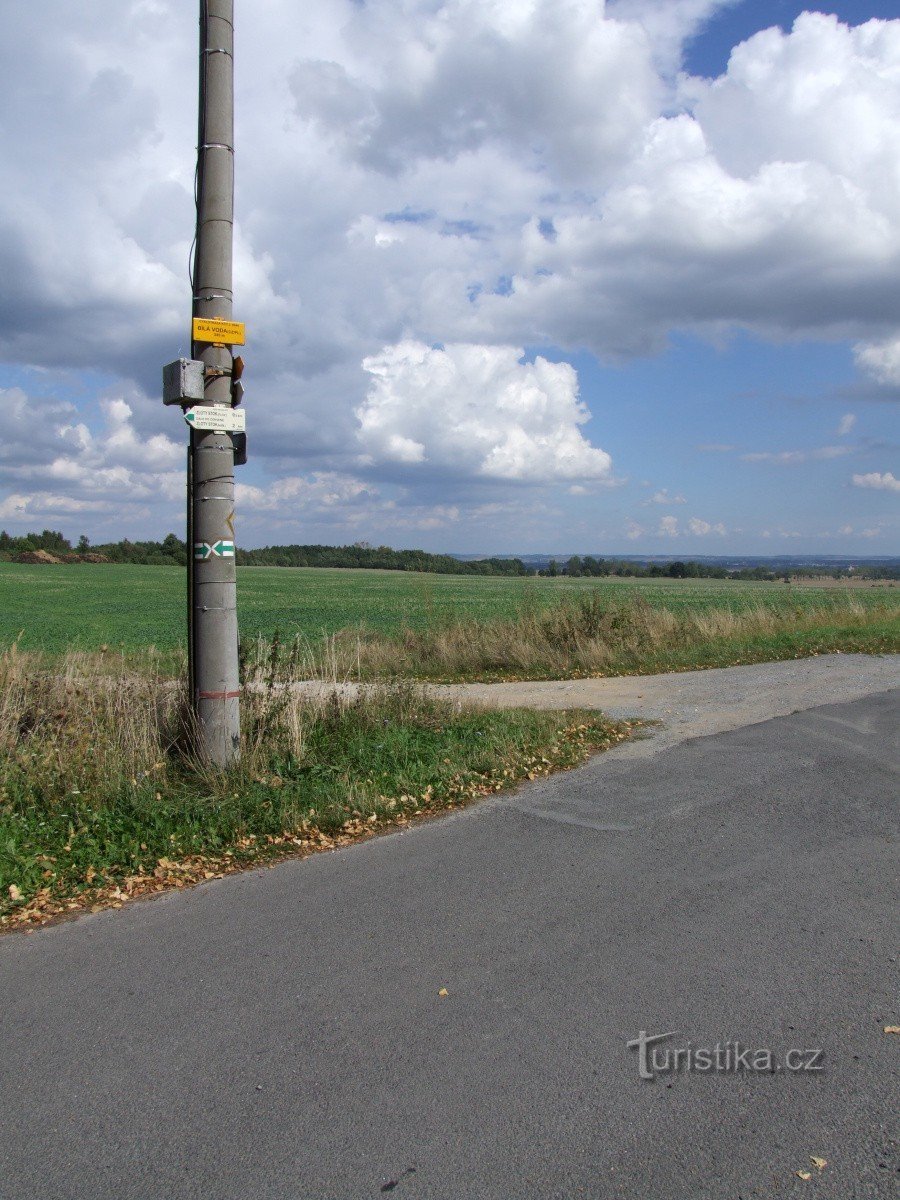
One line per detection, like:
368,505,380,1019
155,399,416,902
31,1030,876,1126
329,593,900,682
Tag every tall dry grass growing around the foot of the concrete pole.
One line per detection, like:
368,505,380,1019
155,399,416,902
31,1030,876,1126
0,637,374,796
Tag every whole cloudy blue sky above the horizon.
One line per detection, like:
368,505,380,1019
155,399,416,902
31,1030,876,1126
0,0,900,557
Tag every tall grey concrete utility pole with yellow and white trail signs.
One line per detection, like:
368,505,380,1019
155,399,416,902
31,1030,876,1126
163,0,245,767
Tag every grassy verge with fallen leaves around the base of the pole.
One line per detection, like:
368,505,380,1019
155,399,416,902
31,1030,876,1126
0,643,634,930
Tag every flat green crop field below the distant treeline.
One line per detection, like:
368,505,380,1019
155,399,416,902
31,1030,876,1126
0,563,896,653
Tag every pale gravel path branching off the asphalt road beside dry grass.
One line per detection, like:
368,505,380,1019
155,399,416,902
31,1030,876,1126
434,654,900,752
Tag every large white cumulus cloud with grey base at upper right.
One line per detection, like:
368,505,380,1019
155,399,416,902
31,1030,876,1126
482,13,900,355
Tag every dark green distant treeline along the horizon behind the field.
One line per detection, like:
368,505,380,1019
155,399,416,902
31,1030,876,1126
0,529,900,581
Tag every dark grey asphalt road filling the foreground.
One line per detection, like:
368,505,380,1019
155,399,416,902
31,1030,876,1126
0,691,900,1200
